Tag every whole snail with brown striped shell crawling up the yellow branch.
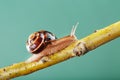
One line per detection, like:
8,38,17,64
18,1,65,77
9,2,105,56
26,23,78,62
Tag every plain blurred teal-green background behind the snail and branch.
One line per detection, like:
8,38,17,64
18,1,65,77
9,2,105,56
0,0,120,80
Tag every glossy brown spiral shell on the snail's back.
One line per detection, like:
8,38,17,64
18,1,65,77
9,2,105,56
26,30,56,54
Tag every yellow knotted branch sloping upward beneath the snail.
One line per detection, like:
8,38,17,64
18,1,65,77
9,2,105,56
0,21,120,80
